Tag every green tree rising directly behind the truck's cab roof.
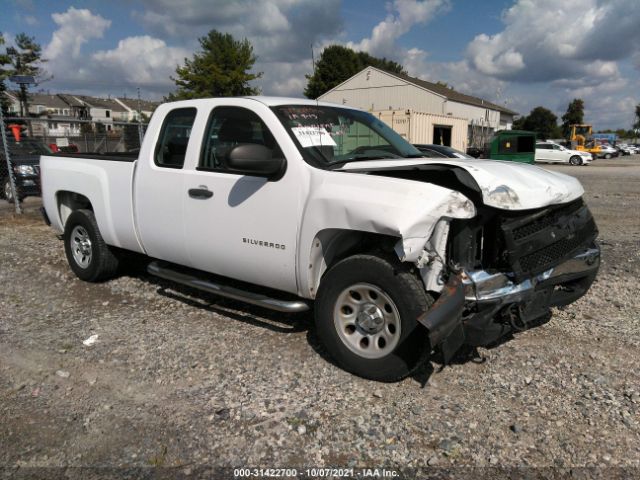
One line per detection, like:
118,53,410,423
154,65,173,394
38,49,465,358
166,30,262,100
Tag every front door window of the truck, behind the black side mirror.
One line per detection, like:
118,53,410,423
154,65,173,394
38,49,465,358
198,107,284,171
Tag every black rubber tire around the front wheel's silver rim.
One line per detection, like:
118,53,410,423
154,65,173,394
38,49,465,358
315,255,433,382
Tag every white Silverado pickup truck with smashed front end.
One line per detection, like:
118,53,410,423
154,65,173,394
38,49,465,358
41,97,600,381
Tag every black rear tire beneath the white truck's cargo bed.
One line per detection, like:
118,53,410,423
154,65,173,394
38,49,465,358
64,210,119,282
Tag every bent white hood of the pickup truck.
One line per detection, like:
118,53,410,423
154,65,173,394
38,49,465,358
339,158,584,210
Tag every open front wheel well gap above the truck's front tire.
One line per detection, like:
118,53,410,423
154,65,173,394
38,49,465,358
308,228,398,298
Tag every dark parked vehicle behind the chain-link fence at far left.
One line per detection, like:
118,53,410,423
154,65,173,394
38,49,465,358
0,135,51,203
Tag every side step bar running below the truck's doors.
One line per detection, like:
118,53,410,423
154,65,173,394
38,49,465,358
147,261,309,313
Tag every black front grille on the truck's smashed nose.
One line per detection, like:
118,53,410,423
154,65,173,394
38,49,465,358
502,200,598,281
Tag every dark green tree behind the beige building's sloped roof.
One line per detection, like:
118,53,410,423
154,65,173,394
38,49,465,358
304,45,407,98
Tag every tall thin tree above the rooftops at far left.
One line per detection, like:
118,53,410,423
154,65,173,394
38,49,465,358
7,33,51,116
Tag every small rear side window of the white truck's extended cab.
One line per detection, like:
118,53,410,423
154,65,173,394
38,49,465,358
155,108,197,168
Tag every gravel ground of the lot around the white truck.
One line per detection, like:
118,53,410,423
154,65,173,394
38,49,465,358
0,156,640,478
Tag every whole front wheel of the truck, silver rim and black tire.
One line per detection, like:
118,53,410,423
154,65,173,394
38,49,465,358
315,255,433,382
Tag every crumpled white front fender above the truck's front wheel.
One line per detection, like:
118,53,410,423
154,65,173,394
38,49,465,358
298,172,476,298
